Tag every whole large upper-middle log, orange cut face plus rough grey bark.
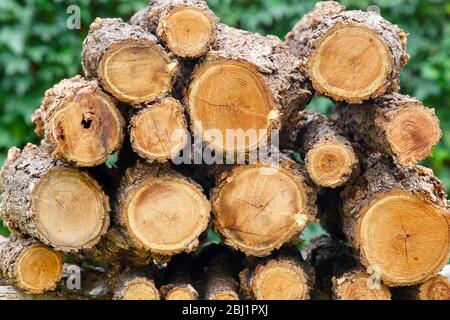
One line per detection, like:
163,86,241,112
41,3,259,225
185,25,311,155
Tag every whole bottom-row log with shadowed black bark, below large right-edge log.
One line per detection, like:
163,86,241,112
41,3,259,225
304,236,391,300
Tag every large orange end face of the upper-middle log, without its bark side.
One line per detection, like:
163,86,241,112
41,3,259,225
187,59,280,153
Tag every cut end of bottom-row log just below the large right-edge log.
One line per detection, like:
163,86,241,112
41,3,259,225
333,268,391,300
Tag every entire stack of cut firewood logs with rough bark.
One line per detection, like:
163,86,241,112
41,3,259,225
0,0,450,300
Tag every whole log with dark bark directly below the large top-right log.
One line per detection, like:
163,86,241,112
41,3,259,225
335,94,442,166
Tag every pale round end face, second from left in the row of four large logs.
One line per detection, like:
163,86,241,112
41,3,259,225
122,177,211,256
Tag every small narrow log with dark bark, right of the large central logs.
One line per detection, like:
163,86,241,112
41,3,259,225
283,111,358,188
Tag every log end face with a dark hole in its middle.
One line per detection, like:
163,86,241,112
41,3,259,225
51,91,125,167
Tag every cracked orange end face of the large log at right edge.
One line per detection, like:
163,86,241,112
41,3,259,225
355,189,450,286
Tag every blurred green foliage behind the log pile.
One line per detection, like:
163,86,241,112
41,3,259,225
0,0,450,237
